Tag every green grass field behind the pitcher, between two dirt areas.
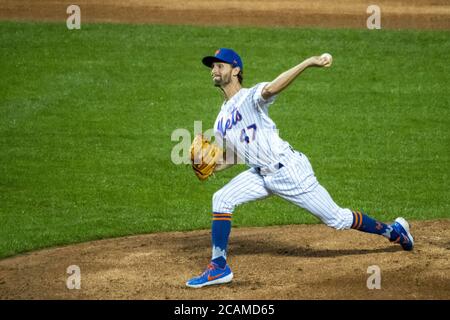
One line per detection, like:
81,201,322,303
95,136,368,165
0,22,450,257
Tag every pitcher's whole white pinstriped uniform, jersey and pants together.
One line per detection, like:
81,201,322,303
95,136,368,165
212,82,353,235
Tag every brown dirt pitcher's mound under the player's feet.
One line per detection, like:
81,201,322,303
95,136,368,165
0,220,450,299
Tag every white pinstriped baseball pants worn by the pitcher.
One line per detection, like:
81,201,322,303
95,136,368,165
213,152,353,229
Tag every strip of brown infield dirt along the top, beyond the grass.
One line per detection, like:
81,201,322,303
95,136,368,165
0,0,450,29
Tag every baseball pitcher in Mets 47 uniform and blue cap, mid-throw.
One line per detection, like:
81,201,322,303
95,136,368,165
186,48,414,288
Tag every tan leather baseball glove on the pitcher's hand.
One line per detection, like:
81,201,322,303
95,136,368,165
189,134,223,181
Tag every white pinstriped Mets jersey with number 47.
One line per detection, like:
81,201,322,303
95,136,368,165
214,82,290,167
